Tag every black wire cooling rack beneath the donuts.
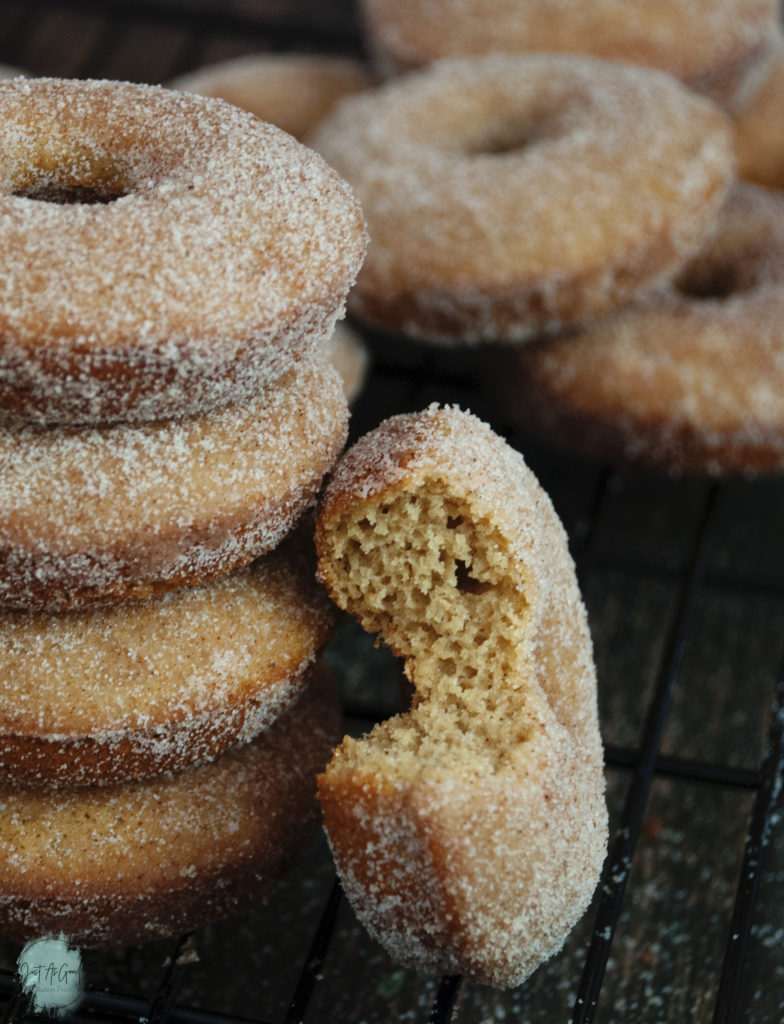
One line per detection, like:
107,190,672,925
0,0,784,1024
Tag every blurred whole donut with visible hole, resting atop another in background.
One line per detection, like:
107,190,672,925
309,54,733,344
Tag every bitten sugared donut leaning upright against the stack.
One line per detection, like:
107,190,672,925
316,407,607,986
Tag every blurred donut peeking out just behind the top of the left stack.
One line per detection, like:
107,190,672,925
169,53,374,141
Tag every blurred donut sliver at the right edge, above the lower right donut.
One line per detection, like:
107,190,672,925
733,34,784,188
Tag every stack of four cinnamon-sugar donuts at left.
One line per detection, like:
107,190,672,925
0,78,365,945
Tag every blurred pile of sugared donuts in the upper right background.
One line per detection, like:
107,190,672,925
300,0,784,474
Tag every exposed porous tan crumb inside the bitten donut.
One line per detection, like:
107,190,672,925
321,481,530,768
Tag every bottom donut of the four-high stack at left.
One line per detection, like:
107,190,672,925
0,663,340,946
